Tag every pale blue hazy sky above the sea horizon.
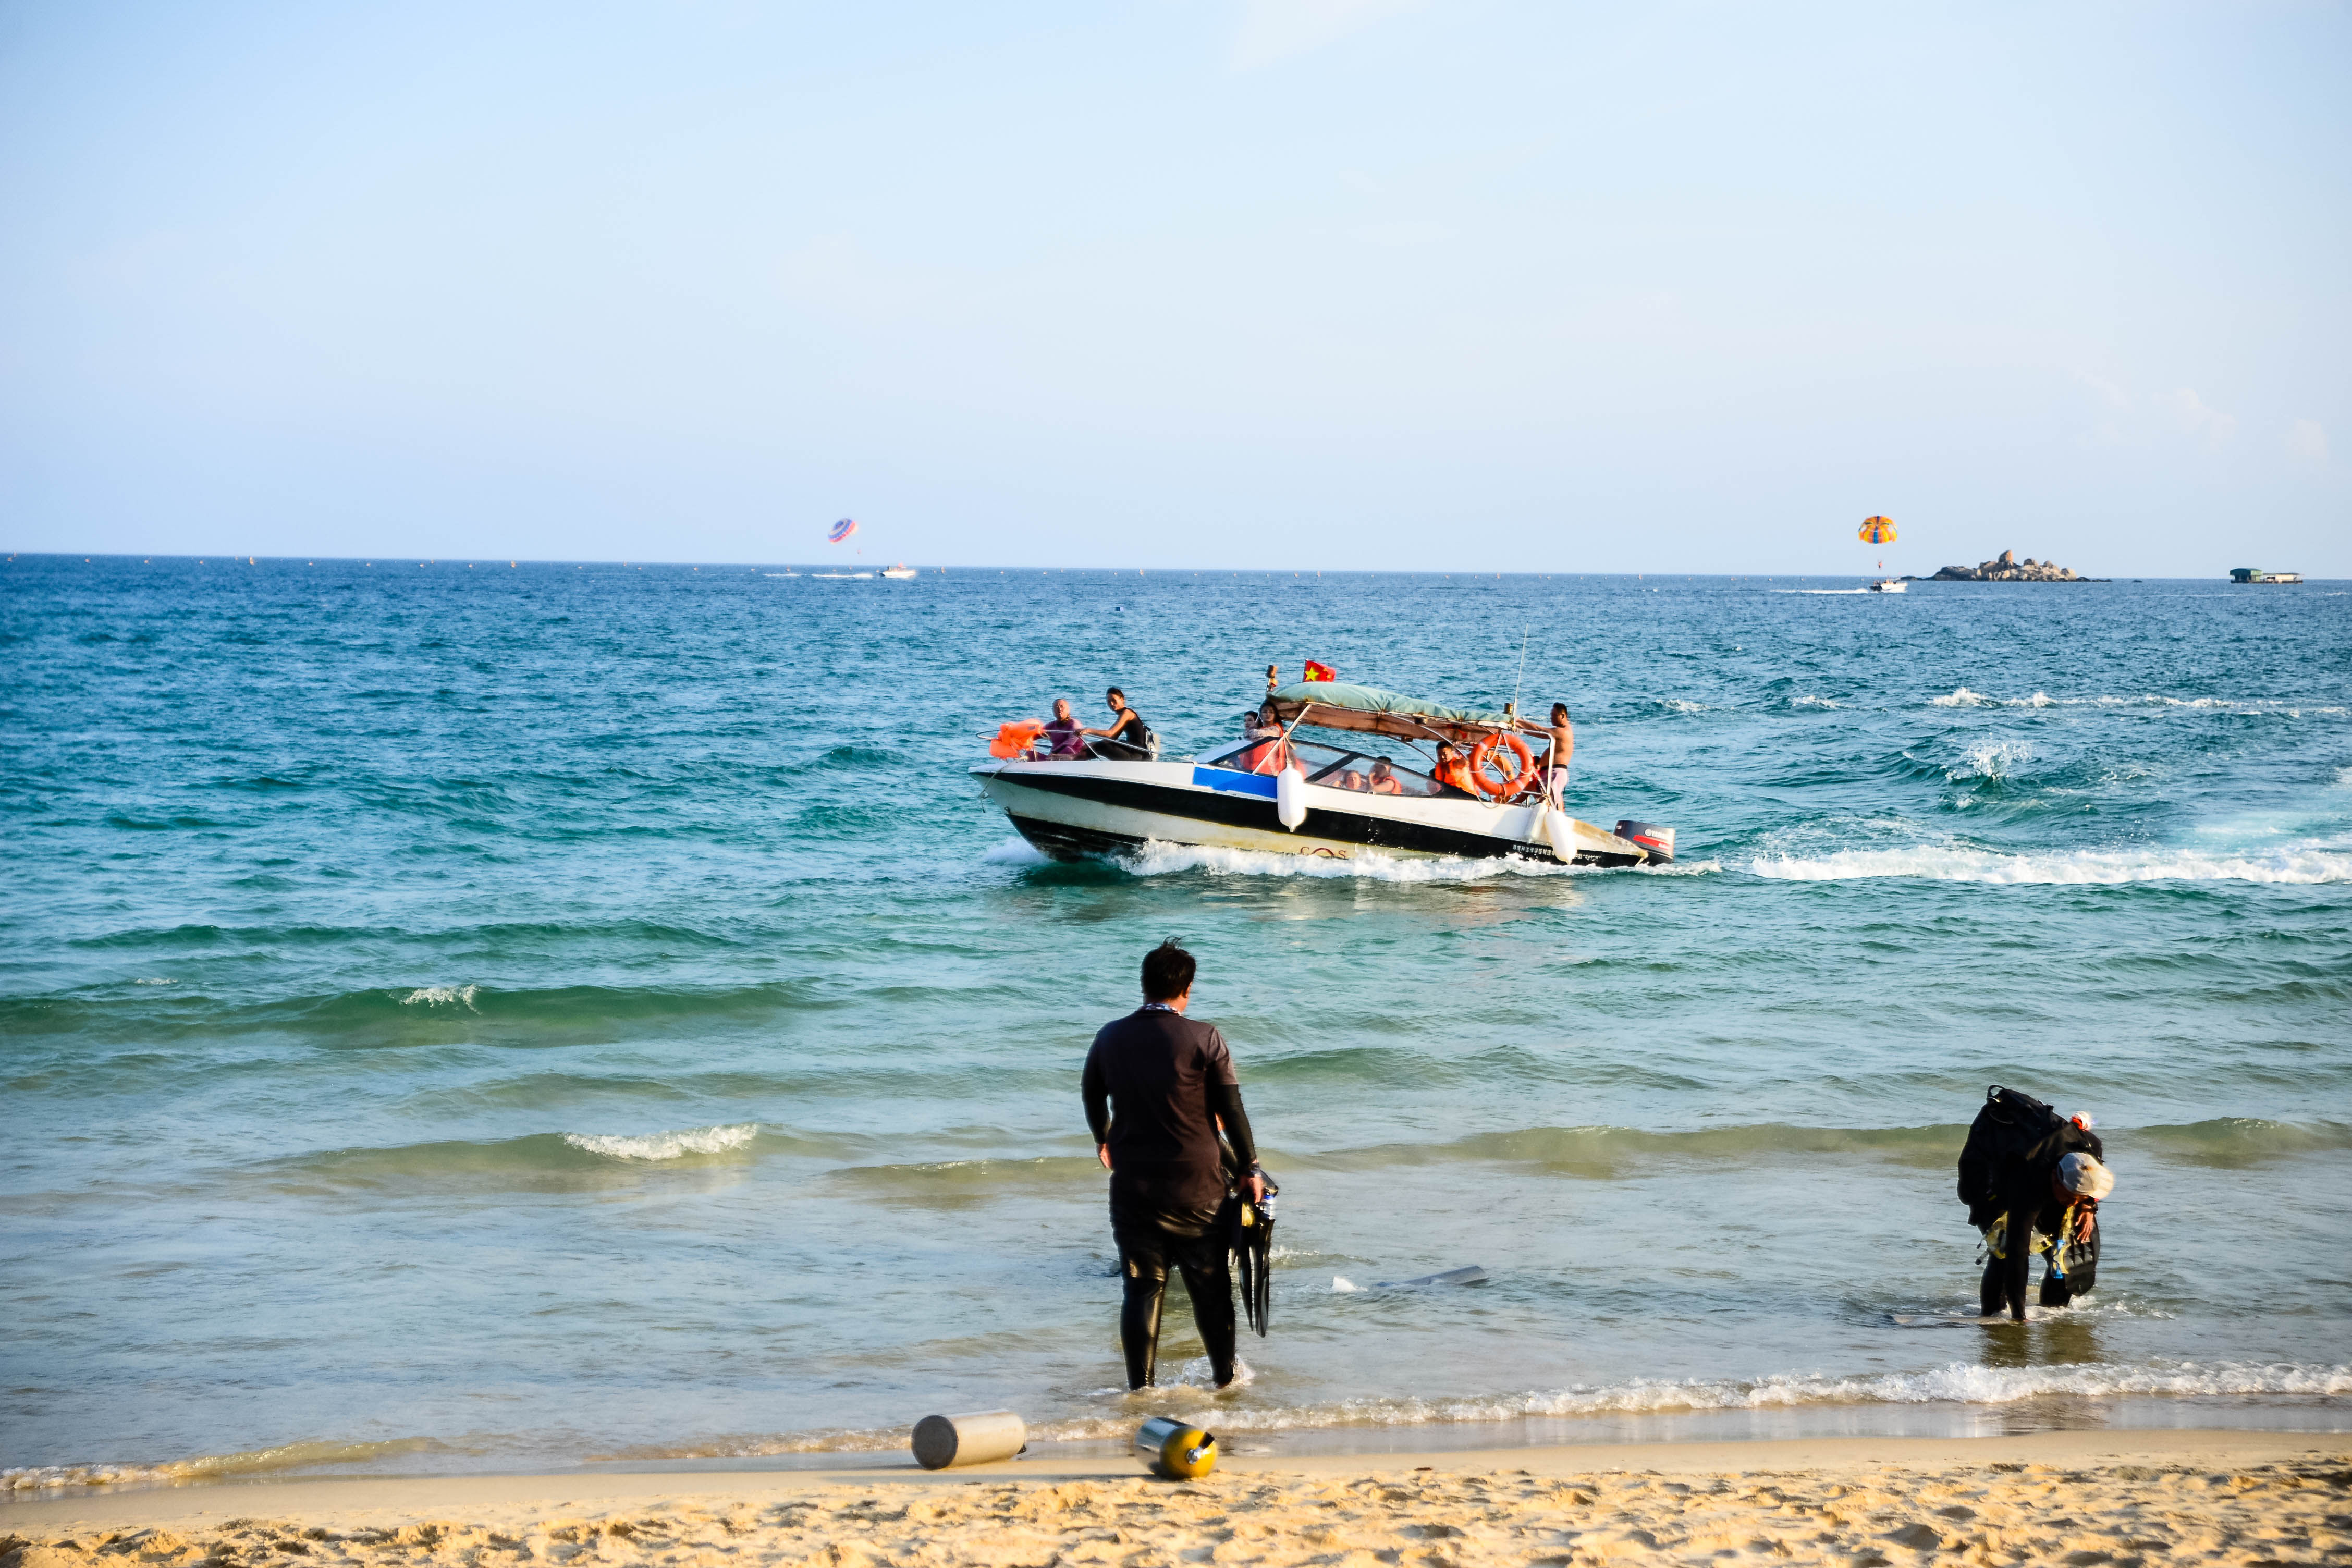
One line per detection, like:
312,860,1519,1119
0,0,2352,576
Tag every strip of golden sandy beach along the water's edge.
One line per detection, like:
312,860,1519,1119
0,1431,2352,1568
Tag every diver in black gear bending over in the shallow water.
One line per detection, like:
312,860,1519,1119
1959,1084,2114,1324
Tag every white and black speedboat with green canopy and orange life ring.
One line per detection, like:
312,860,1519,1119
971,682,1675,865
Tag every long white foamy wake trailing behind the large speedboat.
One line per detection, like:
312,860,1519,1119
1747,844,2352,886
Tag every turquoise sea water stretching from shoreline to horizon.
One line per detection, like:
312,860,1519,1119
0,557,2352,1488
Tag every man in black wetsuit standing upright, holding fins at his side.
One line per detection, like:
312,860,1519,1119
1082,940,1265,1389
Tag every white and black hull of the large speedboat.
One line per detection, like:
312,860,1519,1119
974,762,1649,865
